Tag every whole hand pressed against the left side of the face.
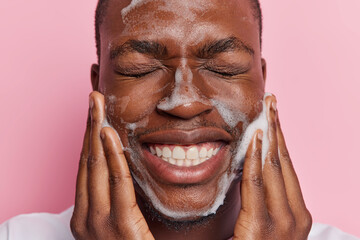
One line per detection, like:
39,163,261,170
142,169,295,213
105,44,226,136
70,92,154,240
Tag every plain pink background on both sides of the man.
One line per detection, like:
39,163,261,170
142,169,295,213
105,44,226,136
0,0,360,236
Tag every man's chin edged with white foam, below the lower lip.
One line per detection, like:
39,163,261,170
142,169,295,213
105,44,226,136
129,146,236,223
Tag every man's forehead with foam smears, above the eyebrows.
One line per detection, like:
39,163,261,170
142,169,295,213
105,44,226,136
100,0,258,54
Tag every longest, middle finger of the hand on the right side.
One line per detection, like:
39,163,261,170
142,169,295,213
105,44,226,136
263,96,292,221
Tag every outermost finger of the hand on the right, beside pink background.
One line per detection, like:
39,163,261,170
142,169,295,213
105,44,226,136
276,110,312,226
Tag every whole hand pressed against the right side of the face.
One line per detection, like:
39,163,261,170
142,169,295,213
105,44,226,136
233,96,312,240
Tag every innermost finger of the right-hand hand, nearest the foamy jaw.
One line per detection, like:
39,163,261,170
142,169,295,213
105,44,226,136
240,130,267,219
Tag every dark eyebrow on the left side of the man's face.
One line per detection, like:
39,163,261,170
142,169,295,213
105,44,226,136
110,39,167,60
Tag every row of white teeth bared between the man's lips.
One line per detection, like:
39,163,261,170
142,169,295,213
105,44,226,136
150,146,220,167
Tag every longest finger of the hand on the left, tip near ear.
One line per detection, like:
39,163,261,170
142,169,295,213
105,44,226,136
88,91,110,217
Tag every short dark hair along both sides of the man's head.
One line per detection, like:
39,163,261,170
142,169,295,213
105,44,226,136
95,0,263,63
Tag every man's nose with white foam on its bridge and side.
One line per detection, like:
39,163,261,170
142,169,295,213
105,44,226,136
157,64,212,120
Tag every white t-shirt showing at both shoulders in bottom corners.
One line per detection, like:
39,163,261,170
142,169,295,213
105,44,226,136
0,207,360,240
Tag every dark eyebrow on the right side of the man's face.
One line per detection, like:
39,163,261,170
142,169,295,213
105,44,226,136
197,37,255,59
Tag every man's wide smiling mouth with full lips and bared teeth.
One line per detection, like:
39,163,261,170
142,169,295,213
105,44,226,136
139,127,233,185
